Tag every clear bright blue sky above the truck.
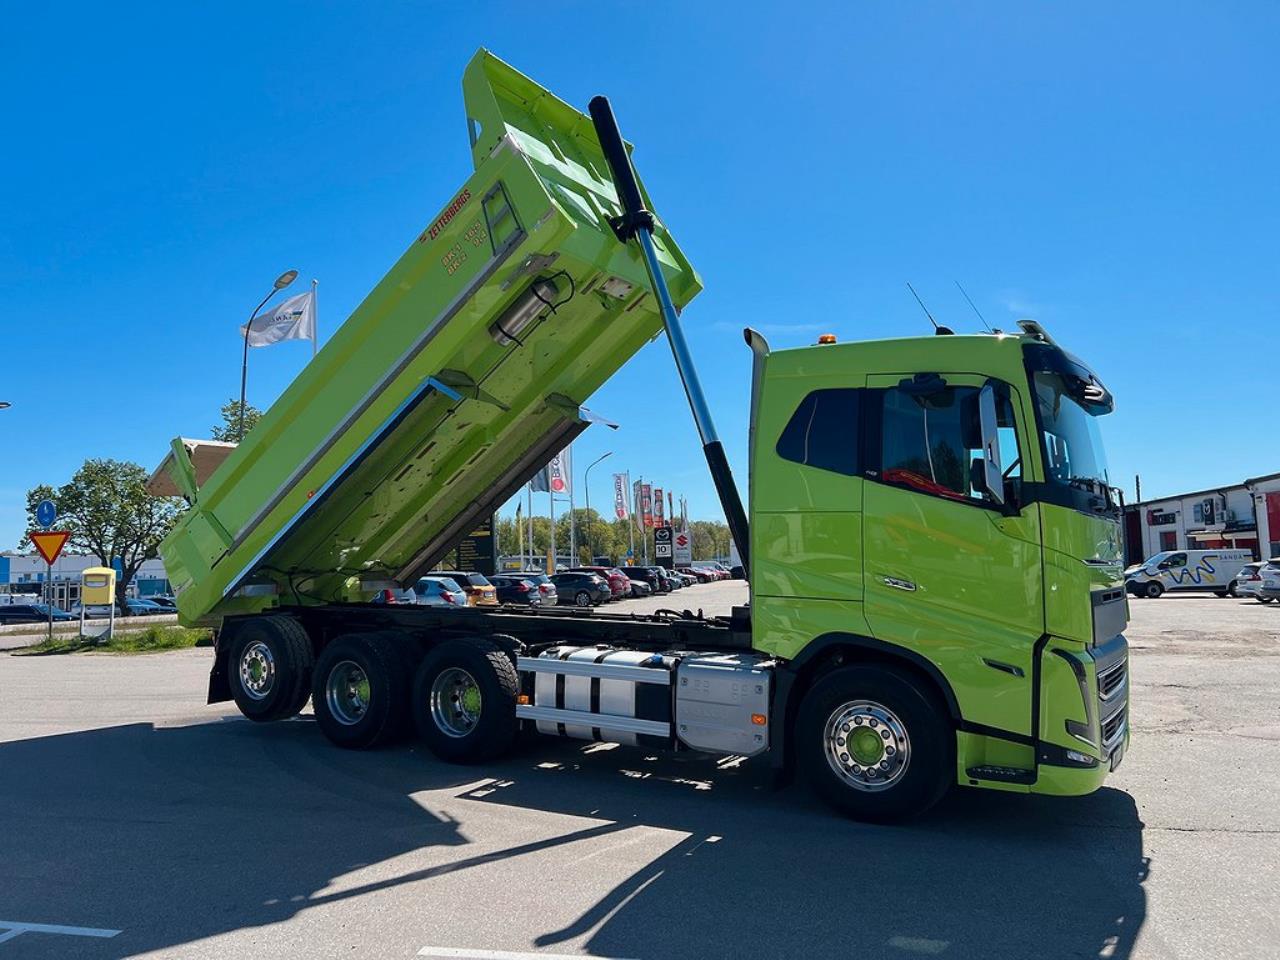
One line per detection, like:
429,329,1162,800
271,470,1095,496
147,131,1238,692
0,0,1280,549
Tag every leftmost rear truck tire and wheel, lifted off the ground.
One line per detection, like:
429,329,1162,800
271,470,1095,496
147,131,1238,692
227,617,315,723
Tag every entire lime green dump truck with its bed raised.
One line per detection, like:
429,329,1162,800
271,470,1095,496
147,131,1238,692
152,51,1129,820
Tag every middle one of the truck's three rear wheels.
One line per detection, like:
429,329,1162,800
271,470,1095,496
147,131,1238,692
311,634,410,750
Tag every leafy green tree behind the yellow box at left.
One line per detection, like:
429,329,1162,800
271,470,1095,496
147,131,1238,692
18,460,182,613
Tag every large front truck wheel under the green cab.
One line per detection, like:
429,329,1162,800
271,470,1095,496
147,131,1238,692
795,666,955,823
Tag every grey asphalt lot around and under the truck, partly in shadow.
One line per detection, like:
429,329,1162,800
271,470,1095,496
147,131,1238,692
0,584,1280,960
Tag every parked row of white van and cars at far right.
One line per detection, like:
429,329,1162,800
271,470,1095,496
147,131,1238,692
1125,550,1280,603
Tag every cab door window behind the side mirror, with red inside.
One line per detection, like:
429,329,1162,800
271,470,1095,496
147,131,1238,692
881,387,1021,502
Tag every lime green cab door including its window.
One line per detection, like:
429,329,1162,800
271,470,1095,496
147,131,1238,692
863,375,1044,735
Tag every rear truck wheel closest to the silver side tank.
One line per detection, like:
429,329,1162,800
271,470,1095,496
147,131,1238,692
413,637,520,763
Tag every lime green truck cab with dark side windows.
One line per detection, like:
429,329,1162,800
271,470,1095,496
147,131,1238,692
748,324,1128,814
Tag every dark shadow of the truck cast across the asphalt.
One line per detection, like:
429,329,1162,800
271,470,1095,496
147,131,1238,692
0,721,1147,960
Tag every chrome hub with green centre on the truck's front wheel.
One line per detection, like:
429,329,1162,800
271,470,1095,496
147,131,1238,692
823,700,911,792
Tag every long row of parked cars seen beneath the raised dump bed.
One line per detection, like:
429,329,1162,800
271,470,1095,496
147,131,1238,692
372,562,731,607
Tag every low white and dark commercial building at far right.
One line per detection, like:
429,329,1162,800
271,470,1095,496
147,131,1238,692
1125,474,1280,563
